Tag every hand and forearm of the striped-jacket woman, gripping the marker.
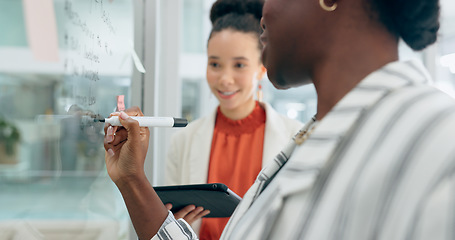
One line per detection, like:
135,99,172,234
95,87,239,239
104,108,168,239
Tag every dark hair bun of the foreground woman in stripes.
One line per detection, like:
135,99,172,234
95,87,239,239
370,0,440,50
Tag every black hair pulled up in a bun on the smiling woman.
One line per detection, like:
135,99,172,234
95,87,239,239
209,0,264,49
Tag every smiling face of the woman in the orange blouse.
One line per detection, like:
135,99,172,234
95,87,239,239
207,29,265,119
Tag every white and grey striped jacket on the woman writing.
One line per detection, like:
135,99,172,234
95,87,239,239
155,61,455,240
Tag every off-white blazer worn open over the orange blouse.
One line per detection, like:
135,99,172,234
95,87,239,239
165,103,303,185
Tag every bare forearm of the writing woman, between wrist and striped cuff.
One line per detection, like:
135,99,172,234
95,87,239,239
116,175,168,240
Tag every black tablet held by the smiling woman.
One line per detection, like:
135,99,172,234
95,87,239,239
154,183,242,217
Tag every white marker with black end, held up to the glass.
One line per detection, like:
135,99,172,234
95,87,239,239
95,116,188,127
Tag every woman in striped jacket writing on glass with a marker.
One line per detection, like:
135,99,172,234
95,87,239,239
105,0,455,240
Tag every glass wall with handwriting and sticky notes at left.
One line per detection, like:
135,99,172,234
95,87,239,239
0,0,134,240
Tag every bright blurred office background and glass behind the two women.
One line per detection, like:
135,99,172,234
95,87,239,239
0,0,455,240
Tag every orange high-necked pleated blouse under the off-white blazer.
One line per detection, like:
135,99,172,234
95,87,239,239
199,102,266,240
